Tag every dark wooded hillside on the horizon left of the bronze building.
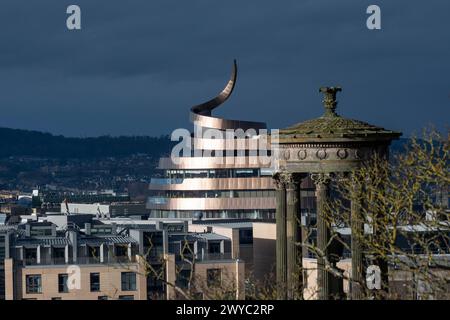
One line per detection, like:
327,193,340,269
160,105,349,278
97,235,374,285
0,128,173,159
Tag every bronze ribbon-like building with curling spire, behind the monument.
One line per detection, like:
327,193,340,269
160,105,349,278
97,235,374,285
147,61,275,219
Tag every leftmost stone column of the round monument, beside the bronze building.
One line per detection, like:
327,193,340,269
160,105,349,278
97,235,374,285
274,174,287,300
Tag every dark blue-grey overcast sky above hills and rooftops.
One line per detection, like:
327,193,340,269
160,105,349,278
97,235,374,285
0,0,450,136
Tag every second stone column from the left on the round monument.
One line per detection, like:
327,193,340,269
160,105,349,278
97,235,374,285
286,174,303,299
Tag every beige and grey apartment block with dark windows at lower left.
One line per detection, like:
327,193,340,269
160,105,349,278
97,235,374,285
0,214,245,300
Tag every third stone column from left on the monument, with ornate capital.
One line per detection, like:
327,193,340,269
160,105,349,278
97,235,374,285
311,173,331,300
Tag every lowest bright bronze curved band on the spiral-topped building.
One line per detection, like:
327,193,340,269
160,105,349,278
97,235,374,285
147,197,276,210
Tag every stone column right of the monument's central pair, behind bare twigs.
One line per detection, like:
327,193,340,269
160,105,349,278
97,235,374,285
350,182,364,300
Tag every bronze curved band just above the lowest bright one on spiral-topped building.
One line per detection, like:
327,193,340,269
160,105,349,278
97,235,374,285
149,177,275,191
